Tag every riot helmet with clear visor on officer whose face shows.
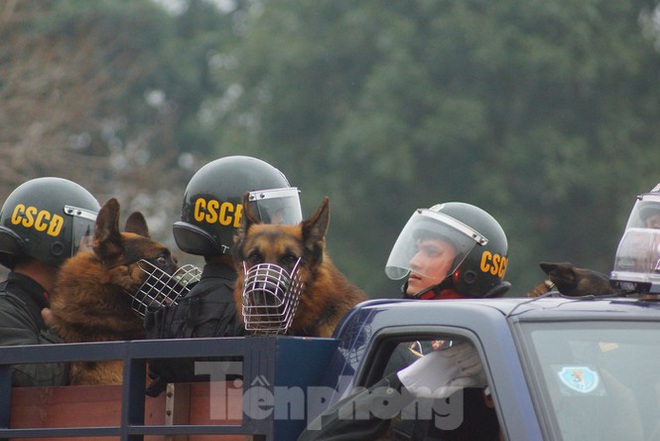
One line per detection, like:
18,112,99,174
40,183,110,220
385,202,510,298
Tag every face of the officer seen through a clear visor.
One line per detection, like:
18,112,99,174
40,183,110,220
406,238,456,295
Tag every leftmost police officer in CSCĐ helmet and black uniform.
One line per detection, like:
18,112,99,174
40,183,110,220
0,177,100,386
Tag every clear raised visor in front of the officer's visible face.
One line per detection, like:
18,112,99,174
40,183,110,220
385,209,488,283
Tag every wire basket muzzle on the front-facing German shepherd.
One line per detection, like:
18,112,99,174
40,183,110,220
242,259,303,334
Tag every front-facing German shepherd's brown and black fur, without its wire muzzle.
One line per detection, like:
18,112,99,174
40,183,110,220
233,197,367,337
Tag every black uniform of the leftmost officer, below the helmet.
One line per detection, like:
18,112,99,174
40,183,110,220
0,272,68,386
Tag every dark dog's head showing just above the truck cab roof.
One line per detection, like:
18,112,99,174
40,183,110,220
527,262,615,297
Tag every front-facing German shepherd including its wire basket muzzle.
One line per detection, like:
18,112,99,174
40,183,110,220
233,197,367,337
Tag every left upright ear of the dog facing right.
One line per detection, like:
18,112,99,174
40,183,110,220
92,198,124,266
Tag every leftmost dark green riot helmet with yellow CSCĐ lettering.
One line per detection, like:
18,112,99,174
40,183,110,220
0,177,100,269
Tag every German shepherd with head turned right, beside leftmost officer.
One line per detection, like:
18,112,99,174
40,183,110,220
50,198,177,384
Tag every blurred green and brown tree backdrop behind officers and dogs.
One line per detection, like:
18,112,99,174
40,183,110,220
0,0,660,296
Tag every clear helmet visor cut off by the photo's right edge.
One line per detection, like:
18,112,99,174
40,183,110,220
610,228,660,293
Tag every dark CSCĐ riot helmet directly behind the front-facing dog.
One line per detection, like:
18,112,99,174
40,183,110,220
172,156,302,256
